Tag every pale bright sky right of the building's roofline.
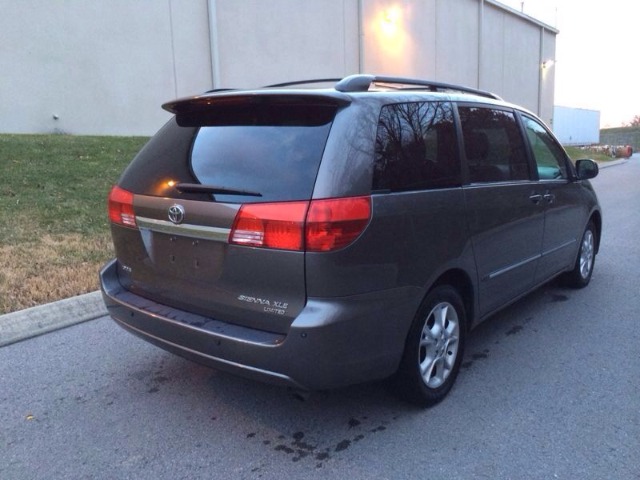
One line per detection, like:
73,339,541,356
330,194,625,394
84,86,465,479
499,0,640,127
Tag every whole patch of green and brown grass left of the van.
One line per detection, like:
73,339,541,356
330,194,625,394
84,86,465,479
0,135,147,313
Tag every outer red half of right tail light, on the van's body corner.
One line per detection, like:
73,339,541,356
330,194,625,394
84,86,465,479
306,197,371,252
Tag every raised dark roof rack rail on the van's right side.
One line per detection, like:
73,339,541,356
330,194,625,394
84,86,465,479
335,74,502,100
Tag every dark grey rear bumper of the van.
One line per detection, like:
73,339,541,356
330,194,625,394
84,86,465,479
100,260,420,390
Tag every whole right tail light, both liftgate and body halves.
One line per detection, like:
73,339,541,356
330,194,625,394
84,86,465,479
229,197,371,252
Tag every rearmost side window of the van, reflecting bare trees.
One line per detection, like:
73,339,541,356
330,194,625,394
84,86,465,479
373,102,461,191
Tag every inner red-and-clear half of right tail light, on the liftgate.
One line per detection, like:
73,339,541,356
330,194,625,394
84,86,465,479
229,202,309,250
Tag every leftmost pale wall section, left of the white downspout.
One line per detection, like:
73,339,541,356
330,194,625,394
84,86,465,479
0,0,211,135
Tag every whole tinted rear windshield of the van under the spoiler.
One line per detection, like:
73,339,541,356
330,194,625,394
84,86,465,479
119,104,337,203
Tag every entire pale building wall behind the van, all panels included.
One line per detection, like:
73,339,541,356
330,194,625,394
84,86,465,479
0,0,557,135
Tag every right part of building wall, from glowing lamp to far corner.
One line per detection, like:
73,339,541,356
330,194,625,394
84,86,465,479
352,0,557,124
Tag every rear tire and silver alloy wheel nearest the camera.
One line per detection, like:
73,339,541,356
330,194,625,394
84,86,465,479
395,285,467,407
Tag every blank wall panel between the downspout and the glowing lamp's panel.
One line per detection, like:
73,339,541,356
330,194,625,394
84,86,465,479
210,0,359,88
